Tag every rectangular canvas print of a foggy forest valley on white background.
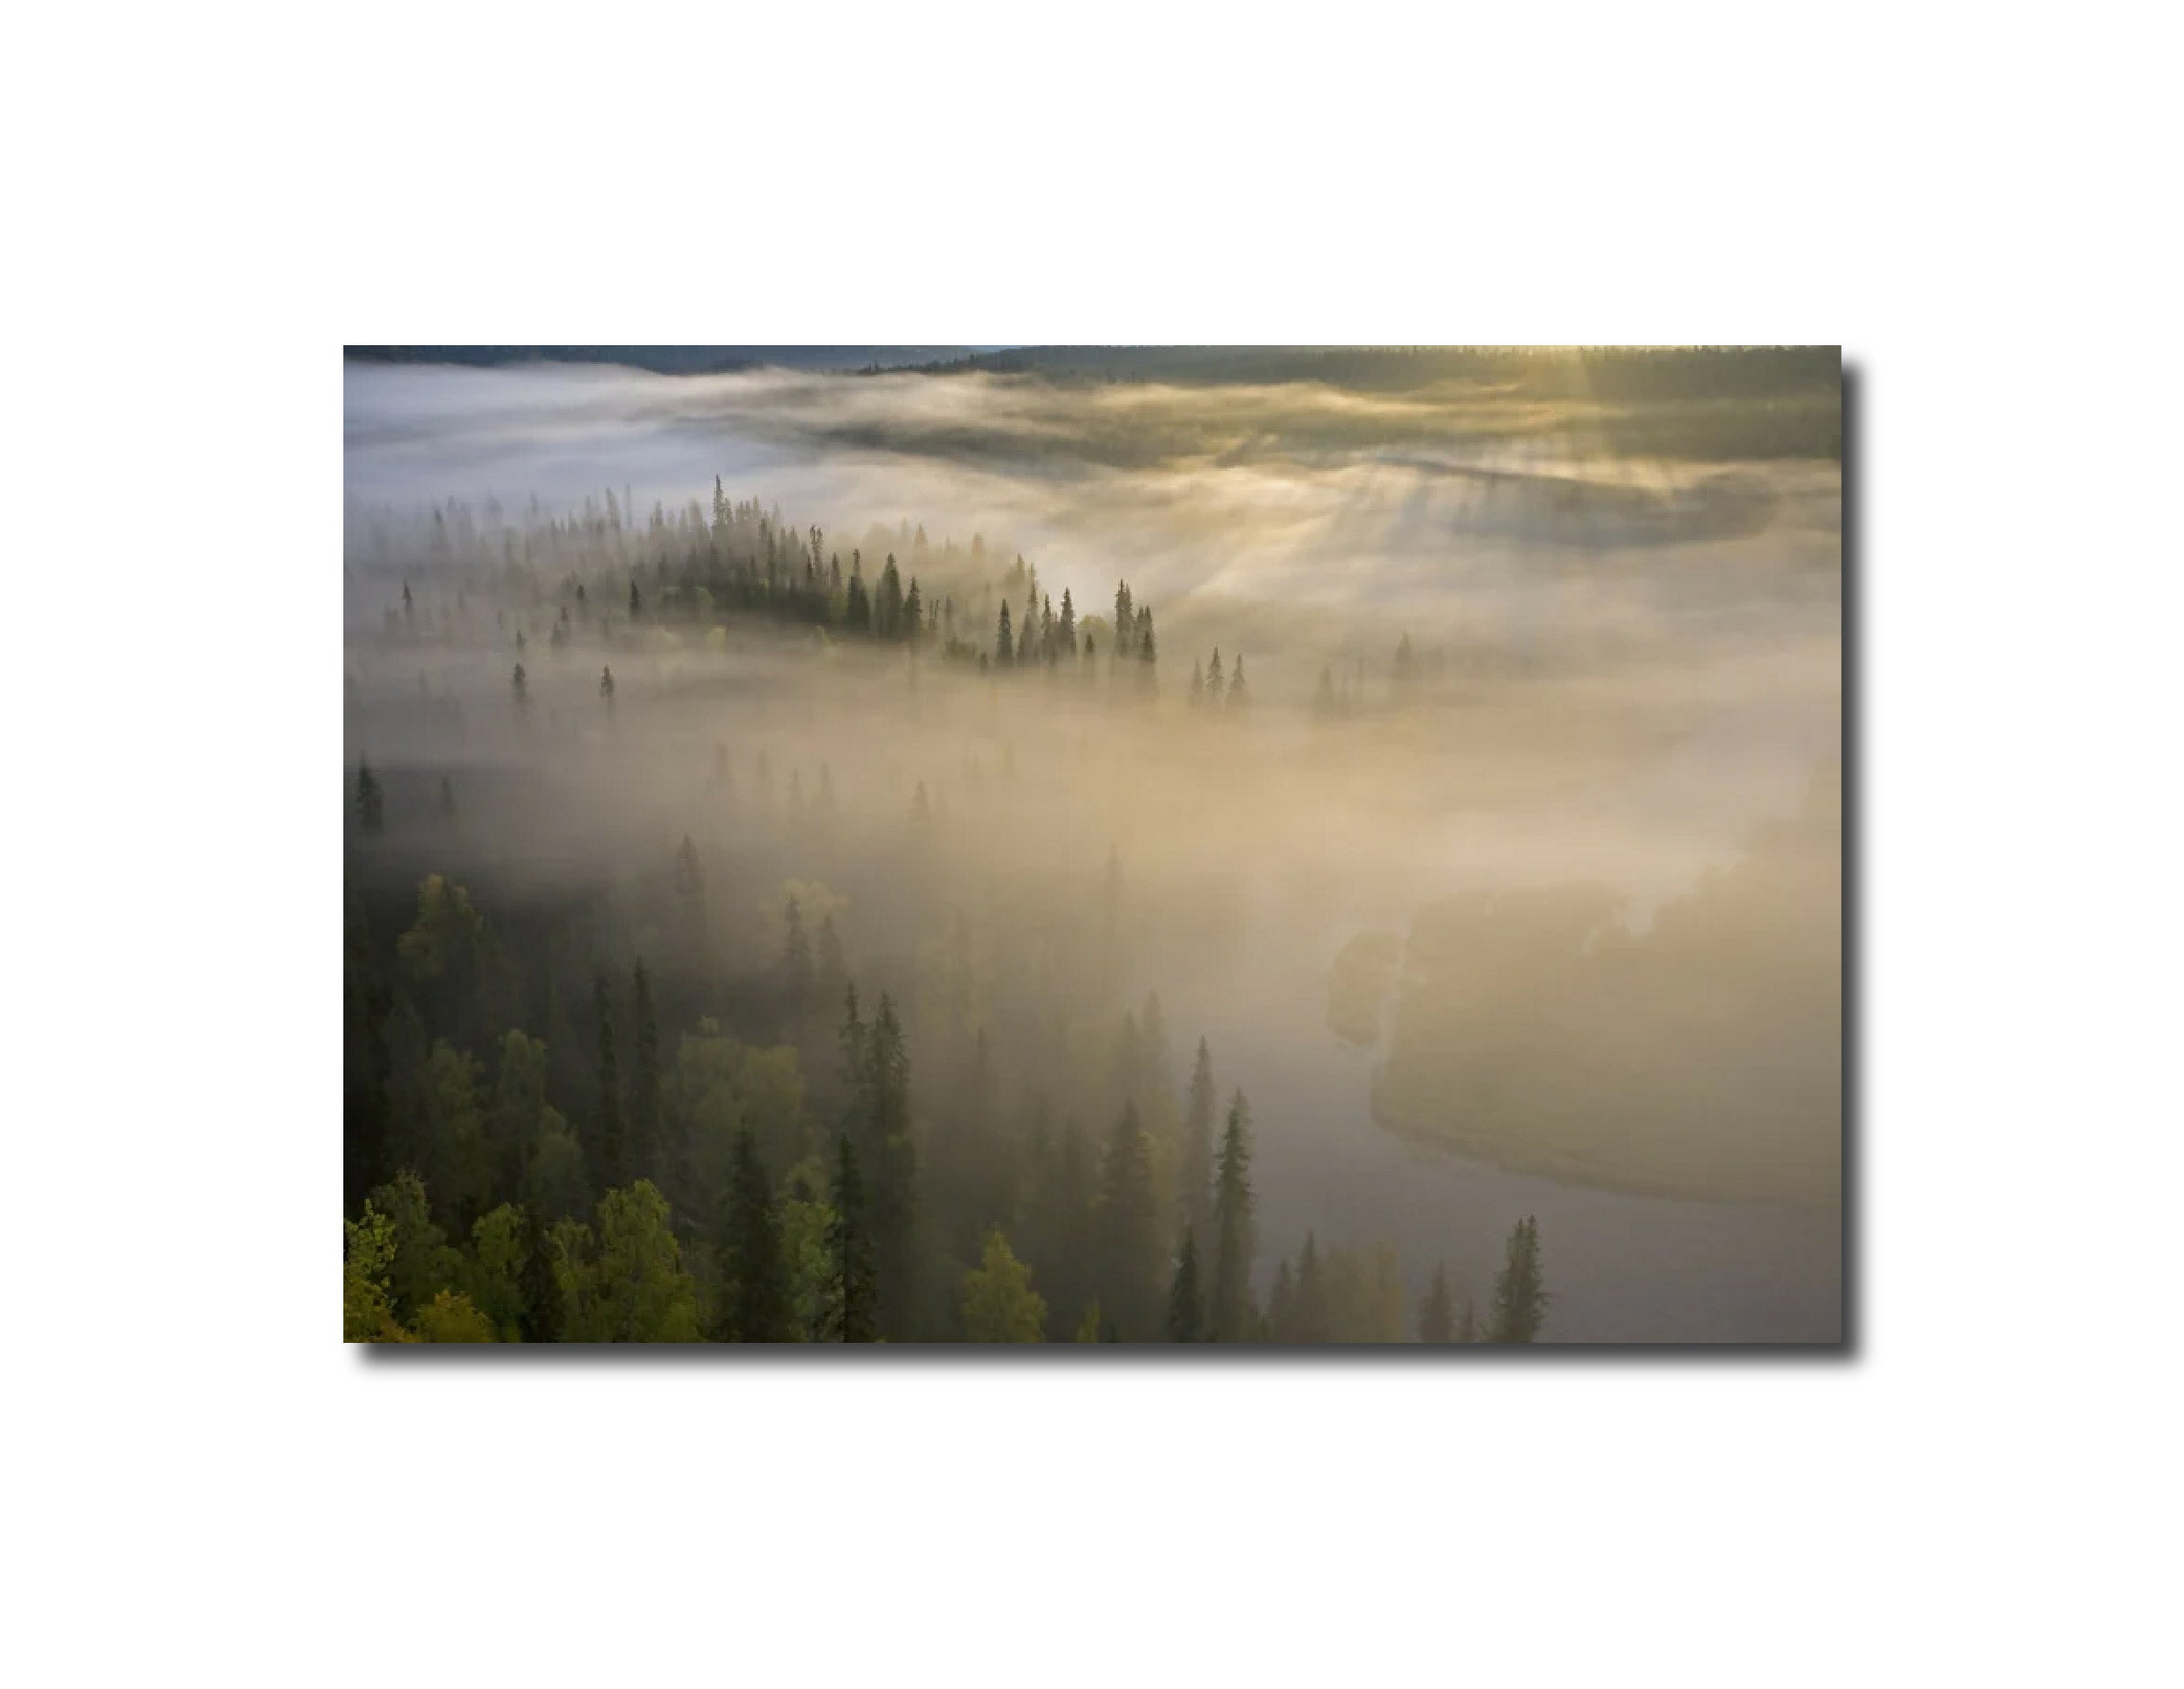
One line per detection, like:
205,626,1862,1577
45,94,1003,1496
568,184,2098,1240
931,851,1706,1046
341,347,1841,1344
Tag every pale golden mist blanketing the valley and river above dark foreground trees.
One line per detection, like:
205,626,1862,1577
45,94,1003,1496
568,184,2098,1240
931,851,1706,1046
343,365,1841,1339
